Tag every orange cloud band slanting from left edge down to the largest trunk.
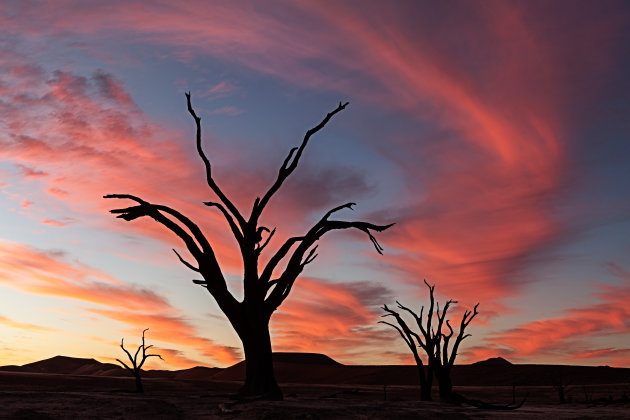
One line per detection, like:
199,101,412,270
0,240,239,364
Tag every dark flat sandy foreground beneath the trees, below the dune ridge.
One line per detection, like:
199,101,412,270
0,372,630,420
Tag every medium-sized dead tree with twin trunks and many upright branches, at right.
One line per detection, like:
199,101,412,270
380,280,479,401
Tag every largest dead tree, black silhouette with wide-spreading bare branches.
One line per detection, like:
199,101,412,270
105,93,392,399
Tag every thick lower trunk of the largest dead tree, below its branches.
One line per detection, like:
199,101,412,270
238,314,282,400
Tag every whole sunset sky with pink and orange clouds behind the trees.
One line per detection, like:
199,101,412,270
0,0,630,368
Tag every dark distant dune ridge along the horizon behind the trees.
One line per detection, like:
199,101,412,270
0,353,630,386
